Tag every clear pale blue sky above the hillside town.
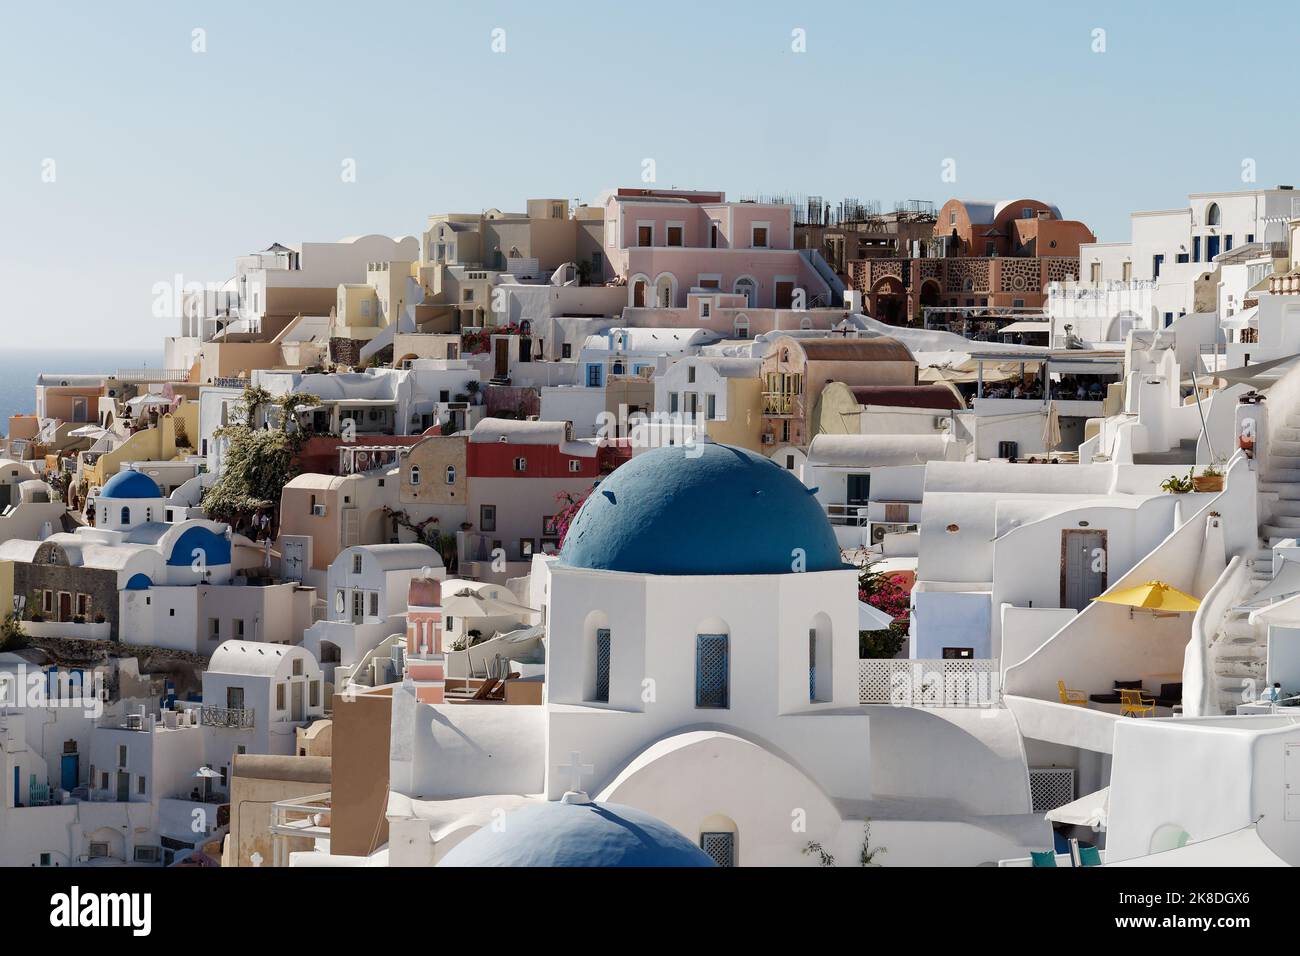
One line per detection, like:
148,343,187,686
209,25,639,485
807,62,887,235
0,0,1300,347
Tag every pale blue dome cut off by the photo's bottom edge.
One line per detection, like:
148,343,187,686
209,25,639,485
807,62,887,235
438,803,715,866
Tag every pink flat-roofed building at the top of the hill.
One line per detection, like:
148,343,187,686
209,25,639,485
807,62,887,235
605,189,839,308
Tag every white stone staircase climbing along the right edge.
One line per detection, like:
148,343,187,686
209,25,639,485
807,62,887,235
1201,415,1300,714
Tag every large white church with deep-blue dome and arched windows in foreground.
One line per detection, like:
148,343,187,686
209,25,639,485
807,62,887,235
387,442,871,866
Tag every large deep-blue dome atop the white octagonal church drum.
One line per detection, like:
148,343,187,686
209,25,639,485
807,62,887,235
560,442,845,575
